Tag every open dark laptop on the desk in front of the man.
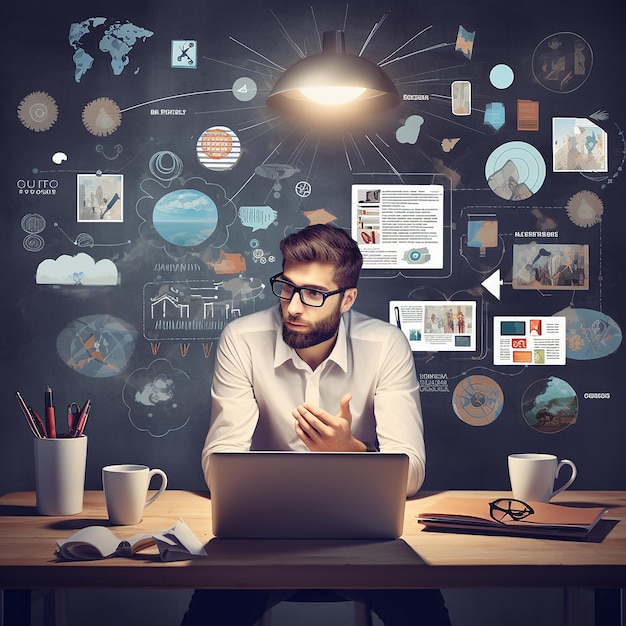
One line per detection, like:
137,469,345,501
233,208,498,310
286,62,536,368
211,451,409,539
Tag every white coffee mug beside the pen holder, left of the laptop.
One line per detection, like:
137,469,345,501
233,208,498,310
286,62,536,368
102,465,167,526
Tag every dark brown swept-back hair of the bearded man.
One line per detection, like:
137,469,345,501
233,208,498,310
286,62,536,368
280,224,363,288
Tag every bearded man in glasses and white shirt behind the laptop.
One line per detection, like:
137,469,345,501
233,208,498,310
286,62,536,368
183,224,450,626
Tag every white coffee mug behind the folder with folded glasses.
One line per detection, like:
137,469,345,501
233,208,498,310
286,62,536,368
509,453,577,502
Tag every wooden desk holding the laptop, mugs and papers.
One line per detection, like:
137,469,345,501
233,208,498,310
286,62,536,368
0,490,626,626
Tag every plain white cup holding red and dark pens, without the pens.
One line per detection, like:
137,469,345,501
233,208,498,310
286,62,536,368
34,435,87,515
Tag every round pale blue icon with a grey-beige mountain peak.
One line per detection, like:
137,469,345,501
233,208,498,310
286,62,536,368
485,141,546,201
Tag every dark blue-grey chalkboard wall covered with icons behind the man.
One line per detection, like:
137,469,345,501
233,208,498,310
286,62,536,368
0,0,626,492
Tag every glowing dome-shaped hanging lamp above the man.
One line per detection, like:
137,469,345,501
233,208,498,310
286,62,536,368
267,31,400,122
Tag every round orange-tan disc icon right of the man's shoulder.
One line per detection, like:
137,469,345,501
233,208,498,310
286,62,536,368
452,376,504,426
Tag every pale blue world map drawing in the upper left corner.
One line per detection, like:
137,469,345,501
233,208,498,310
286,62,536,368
69,17,154,83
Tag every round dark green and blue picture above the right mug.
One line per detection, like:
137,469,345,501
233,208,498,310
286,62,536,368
522,376,578,434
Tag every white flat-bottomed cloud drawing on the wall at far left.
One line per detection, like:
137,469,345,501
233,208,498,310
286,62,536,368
35,252,118,286
